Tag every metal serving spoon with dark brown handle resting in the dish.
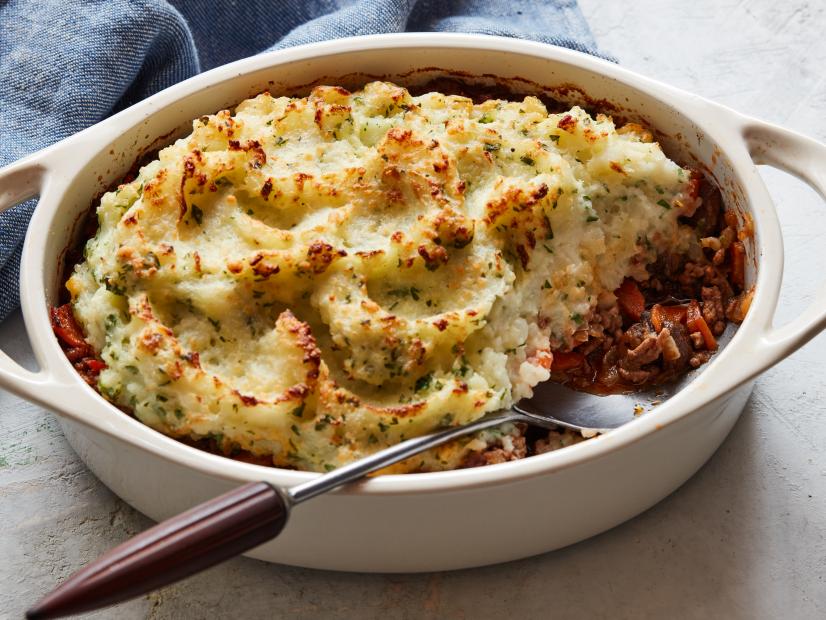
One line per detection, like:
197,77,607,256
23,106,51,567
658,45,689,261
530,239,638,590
26,398,633,619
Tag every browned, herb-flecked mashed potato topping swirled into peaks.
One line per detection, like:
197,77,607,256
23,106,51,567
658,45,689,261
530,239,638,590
67,82,696,471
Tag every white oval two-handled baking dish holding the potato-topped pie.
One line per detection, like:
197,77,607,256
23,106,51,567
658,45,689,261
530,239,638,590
0,34,826,572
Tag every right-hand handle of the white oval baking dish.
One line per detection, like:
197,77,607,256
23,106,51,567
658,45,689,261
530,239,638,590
741,119,826,376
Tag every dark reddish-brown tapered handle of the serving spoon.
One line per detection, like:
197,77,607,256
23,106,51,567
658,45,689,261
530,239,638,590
26,482,289,619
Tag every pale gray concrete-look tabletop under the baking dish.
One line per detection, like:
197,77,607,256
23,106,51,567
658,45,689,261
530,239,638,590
0,0,826,619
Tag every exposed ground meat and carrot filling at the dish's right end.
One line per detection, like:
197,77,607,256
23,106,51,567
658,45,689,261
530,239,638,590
551,181,751,393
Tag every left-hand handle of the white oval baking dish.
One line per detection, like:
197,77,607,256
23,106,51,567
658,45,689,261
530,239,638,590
0,152,61,404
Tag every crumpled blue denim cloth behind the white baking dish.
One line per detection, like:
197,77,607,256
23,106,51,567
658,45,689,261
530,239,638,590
0,0,604,320
